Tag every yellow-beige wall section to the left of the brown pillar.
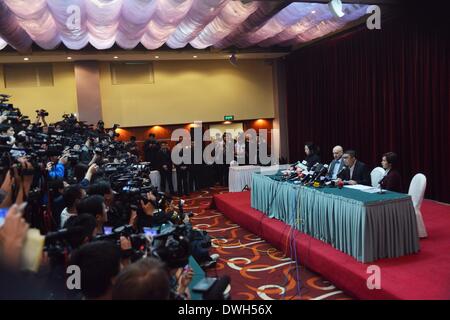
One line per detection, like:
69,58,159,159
0,63,77,123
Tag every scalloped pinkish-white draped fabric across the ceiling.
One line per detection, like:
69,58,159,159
0,0,368,51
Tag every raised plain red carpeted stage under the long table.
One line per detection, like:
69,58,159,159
214,192,450,299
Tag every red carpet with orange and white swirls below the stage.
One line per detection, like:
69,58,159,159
180,187,351,300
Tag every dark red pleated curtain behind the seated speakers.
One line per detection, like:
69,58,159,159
286,19,450,202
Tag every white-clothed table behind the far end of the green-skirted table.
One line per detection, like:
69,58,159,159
228,164,289,192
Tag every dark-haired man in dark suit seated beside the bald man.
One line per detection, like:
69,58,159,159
338,150,370,186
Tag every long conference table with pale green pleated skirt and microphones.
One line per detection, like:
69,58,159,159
251,173,420,263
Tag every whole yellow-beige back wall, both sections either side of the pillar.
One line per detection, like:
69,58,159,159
0,60,274,127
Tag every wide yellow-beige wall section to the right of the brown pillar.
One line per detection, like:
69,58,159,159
100,60,274,127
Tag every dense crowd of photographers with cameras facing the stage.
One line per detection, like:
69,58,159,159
0,95,216,299
